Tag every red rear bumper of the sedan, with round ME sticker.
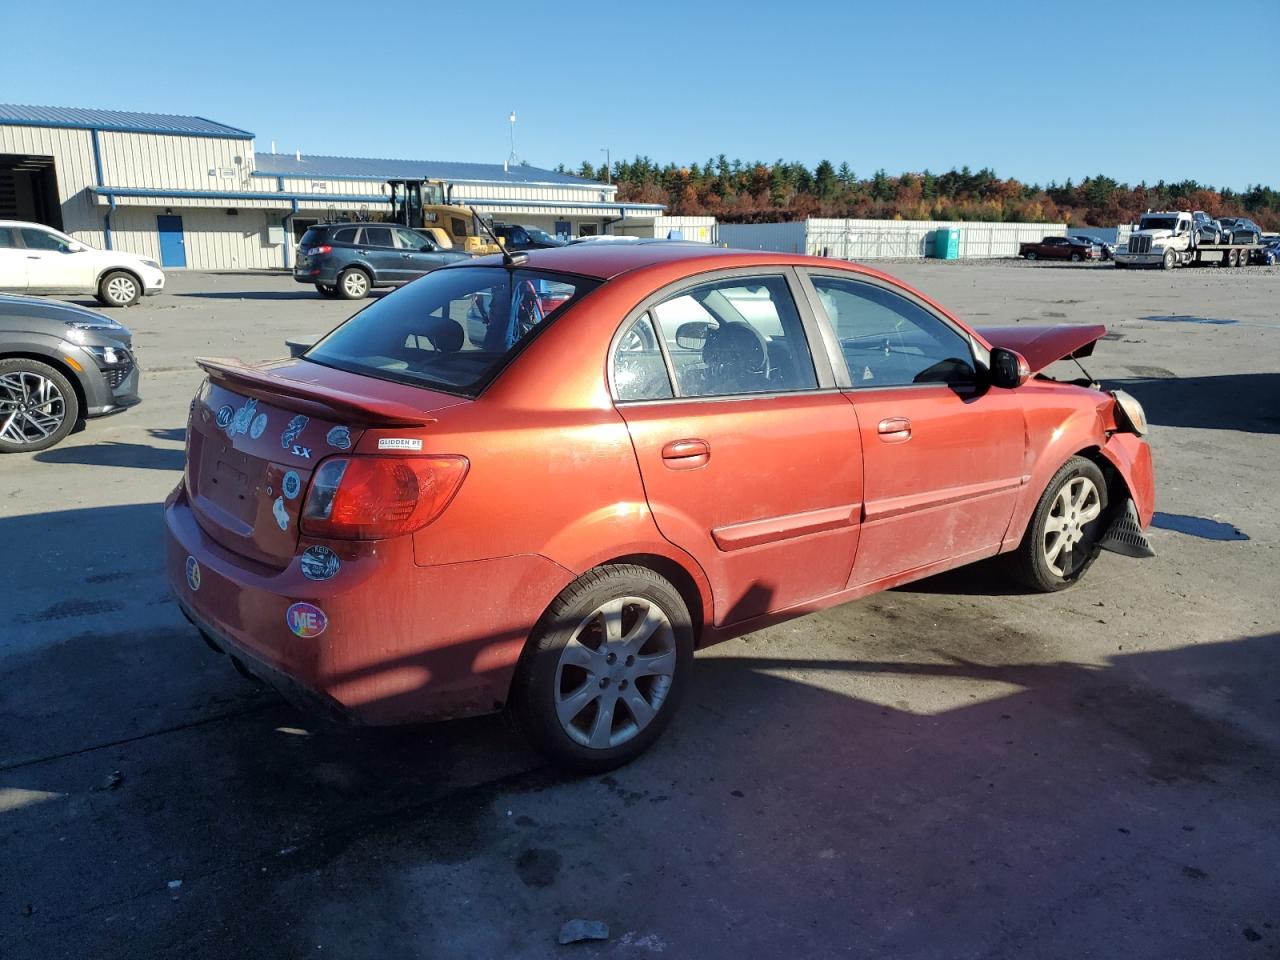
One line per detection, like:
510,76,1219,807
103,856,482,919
165,485,566,724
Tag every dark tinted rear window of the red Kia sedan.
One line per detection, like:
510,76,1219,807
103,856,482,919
306,266,599,397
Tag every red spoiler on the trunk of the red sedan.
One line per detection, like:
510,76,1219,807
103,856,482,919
196,357,435,426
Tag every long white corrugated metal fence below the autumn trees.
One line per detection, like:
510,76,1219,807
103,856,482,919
719,219,1066,260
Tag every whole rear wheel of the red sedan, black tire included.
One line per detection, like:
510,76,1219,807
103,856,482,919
511,563,694,773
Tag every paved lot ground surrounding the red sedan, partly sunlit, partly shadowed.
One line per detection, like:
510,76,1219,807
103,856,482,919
0,261,1280,960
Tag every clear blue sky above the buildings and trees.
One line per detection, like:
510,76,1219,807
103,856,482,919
0,0,1280,188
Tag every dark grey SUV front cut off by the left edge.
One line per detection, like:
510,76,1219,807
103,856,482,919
0,294,138,453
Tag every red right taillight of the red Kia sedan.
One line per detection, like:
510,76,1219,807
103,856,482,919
302,456,468,540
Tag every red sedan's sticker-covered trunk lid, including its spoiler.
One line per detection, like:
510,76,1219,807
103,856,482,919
186,358,463,568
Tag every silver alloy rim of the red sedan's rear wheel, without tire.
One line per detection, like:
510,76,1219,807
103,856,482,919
554,596,677,750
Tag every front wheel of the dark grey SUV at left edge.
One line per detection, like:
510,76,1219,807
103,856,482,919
0,358,79,453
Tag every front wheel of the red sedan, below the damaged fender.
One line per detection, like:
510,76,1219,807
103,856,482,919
1009,457,1107,593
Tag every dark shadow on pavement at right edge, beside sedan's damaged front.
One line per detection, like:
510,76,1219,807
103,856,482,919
1105,372,1280,434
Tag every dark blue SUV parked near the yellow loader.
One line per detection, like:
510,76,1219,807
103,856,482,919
293,223,471,300
